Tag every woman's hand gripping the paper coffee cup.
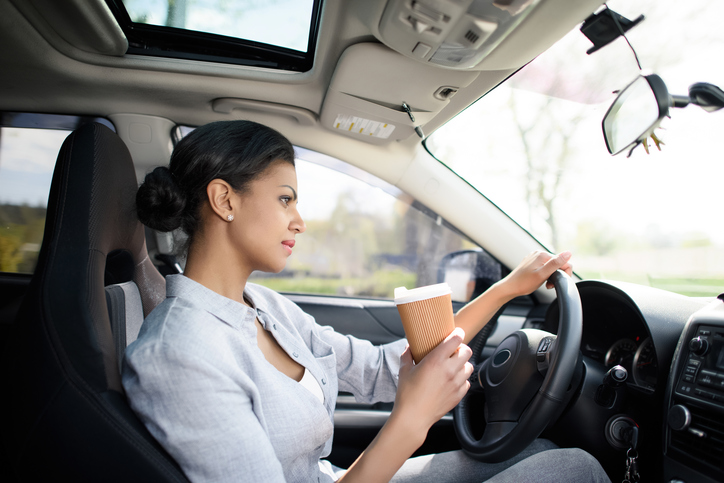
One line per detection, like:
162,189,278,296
392,328,473,439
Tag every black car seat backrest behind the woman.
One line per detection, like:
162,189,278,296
0,124,187,482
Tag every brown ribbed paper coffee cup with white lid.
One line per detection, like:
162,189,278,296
395,283,455,364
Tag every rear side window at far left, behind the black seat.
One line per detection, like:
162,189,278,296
0,113,112,273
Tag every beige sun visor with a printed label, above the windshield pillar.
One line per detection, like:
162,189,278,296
321,43,479,144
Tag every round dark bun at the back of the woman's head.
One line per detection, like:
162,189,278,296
136,166,186,232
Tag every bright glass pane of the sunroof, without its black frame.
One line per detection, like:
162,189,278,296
123,0,314,52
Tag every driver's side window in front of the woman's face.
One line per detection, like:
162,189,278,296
250,148,501,301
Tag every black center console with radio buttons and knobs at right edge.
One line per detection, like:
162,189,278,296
663,294,724,483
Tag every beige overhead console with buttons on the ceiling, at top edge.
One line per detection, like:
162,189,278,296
370,0,603,71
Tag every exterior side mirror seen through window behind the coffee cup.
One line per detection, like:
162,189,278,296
437,250,503,302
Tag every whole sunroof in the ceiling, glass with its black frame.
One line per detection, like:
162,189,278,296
107,0,321,71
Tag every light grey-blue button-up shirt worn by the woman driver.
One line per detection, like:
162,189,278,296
123,275,406,482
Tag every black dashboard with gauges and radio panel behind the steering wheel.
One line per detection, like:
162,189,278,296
536,280,724,483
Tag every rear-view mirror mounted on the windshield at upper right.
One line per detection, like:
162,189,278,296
603,74,671,155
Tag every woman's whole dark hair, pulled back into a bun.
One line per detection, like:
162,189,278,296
136,121,294,243
